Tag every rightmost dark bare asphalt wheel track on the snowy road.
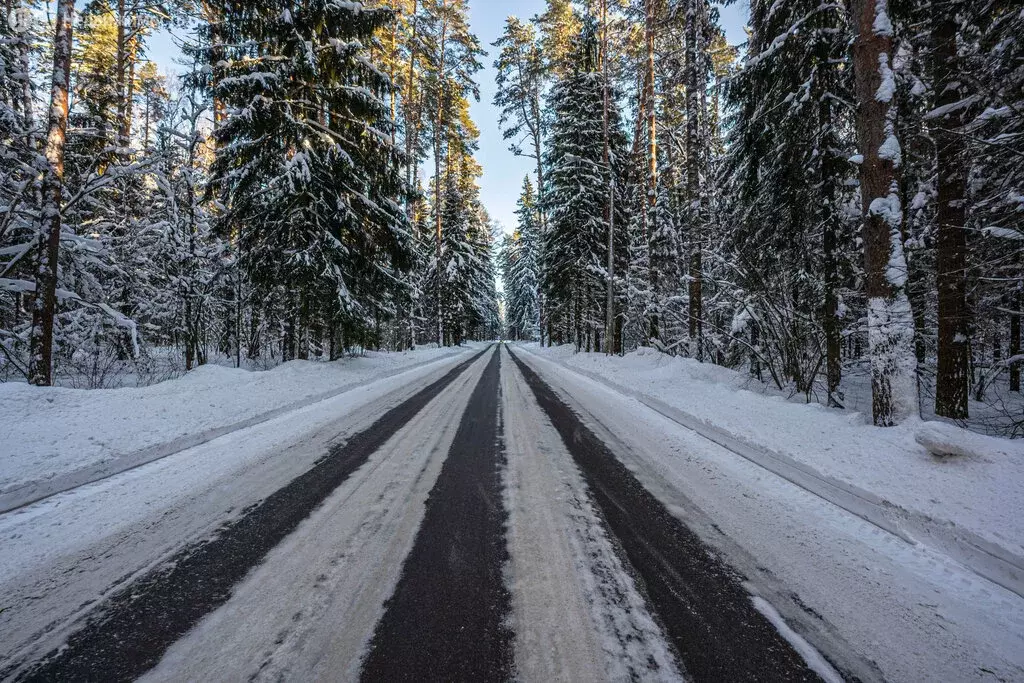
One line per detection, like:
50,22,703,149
510,351,819,681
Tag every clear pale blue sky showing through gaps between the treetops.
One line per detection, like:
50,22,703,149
150,0,749,230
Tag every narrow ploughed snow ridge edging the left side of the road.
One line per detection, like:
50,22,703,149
0,351,475,514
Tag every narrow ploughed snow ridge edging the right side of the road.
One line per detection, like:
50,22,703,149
516,346,1024,597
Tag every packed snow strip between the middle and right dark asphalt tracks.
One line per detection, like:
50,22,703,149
502,348,683,681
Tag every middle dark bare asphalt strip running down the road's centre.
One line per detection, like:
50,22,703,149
362,350,513,683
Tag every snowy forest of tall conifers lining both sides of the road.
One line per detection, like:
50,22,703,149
0,0,1024,435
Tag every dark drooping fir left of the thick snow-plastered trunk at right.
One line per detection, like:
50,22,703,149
722,1,856,402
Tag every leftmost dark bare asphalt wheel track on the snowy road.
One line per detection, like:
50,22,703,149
6,347,494,681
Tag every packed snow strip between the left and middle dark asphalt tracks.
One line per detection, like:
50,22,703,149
144,356,488,681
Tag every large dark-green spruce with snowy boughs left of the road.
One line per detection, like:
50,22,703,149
201,0,412,357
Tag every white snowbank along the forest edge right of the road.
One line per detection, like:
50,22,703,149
523,344,1024,556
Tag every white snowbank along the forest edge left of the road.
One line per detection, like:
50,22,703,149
0,347,468,494
